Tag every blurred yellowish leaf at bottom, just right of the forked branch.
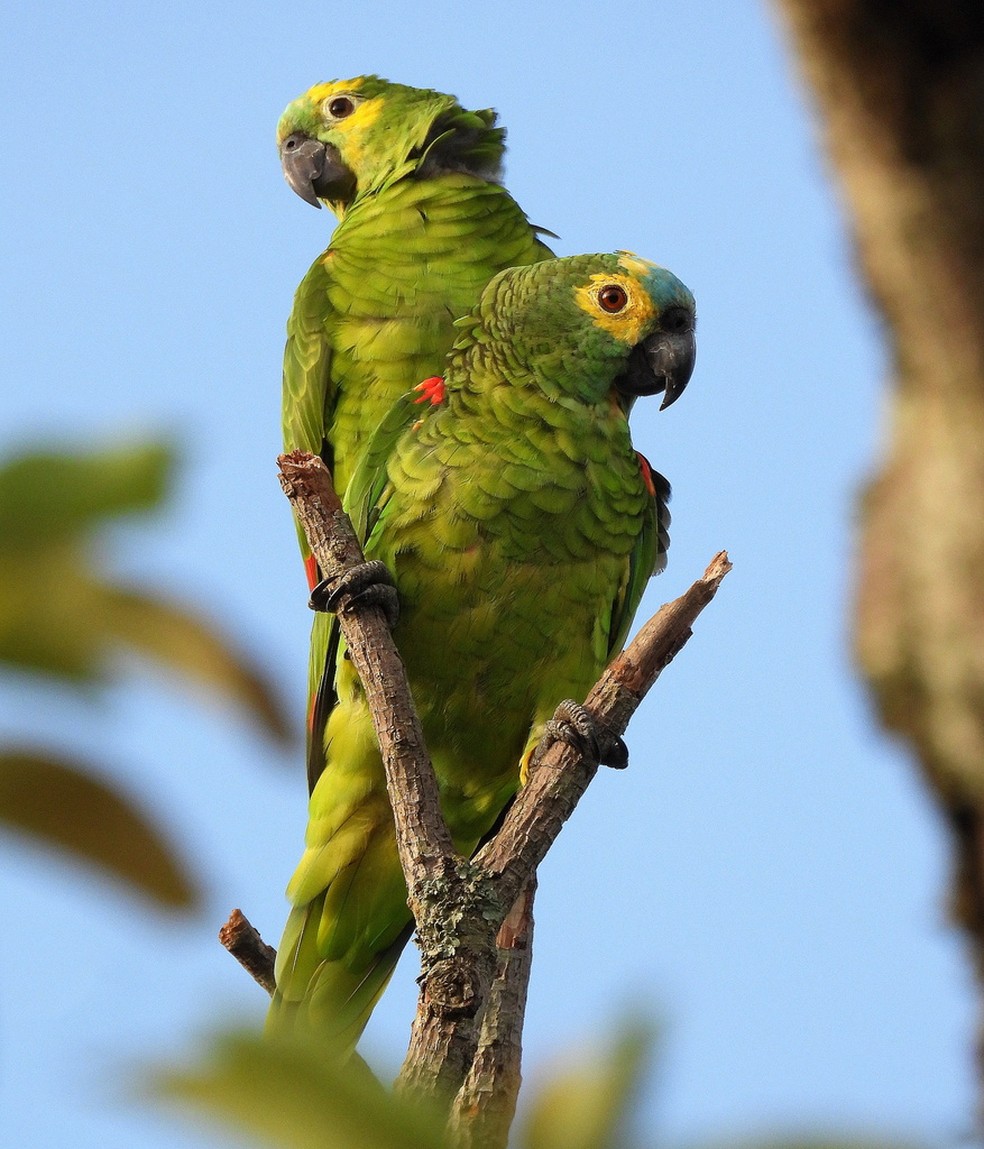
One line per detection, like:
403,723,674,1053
518,1024,654,1149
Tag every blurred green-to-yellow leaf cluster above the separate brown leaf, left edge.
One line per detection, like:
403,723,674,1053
0,444,292,741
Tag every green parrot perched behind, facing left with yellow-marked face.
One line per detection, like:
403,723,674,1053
277,76,552,787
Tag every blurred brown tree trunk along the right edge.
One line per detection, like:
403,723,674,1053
778,0,984,1084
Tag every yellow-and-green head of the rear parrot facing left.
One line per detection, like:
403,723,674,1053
277,76,506,210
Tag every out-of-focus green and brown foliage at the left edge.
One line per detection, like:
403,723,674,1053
0,442,289,909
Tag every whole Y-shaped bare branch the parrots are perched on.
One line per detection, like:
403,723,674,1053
272,452,731,1149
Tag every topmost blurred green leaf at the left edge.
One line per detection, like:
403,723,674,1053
0,442,175,550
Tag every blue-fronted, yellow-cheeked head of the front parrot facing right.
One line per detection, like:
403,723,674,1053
479,252,697,412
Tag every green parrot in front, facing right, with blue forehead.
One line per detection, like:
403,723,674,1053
269,253,695,1052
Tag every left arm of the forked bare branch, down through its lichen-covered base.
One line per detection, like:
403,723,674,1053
278,452,503,1102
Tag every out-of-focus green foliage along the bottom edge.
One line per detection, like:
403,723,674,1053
155,1025,916,1149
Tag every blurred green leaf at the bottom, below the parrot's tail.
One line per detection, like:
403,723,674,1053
155,1033,445,1149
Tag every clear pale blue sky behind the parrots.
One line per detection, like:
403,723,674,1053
0,0,974,1149
